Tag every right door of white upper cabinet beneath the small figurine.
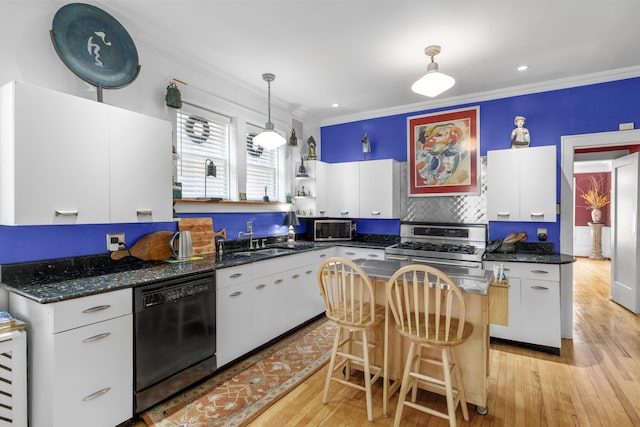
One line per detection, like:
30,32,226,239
515,146,556,222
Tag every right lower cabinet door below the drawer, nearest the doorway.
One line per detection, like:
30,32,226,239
520,279,561,348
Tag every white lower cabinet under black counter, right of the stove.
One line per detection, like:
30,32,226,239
484,261,562,349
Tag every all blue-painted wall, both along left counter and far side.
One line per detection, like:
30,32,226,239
5,78,640,264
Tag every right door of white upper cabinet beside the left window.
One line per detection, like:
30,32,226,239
109,108,173,222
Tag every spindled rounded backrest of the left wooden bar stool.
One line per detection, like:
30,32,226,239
318,257,375,327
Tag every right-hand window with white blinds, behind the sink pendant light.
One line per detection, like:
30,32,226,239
246,124,283,202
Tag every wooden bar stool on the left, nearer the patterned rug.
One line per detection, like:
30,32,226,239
318,257,384,421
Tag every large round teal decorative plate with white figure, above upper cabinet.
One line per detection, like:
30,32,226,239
50,3,140,102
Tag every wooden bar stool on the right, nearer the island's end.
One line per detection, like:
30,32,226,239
387,265,473,427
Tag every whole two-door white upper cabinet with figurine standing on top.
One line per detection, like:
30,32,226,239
487,145,556,222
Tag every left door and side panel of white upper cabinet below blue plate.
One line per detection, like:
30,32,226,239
6,82,109,225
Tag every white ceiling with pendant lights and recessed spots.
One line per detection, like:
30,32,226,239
95,0,640,122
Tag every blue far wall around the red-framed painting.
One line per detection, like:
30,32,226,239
321,78,640,249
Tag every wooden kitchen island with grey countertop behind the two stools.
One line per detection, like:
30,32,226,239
354,259,491,414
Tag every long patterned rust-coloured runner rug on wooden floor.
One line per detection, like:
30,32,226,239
142,318,337,427
